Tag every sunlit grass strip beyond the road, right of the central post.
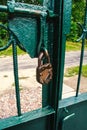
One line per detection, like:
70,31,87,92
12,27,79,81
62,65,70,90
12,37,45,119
66,41,87,51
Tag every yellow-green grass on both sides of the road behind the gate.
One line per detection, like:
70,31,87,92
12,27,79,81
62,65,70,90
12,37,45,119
0,41,87,77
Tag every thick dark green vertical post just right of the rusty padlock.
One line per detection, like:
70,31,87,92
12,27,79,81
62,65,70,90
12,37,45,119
43,0,65,130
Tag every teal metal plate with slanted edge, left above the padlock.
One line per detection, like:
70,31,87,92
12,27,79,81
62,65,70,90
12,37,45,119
9,17,39,57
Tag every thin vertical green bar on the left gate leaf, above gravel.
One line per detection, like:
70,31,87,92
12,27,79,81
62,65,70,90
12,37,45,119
12,40,21,116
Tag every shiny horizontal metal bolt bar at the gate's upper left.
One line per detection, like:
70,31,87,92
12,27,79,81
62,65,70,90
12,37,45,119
0,5,47,16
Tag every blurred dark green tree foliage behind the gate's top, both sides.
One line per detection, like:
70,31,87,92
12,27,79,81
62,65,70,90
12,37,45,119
0,0,86,45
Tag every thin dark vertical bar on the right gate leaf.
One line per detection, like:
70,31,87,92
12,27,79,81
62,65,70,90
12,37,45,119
76,0,87,97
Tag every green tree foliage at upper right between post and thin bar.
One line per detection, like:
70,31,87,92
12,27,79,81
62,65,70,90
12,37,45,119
67,0,86,41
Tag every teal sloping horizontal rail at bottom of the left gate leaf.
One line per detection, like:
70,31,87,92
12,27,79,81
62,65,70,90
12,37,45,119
0,106,55,130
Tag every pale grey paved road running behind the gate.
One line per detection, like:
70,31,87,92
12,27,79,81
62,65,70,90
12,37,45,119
0,51,87,71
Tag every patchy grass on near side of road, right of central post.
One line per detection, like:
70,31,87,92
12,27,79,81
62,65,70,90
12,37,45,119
64,65,87,77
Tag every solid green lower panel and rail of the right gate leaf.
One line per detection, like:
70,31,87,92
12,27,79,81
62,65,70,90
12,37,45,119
58,93,87,130
